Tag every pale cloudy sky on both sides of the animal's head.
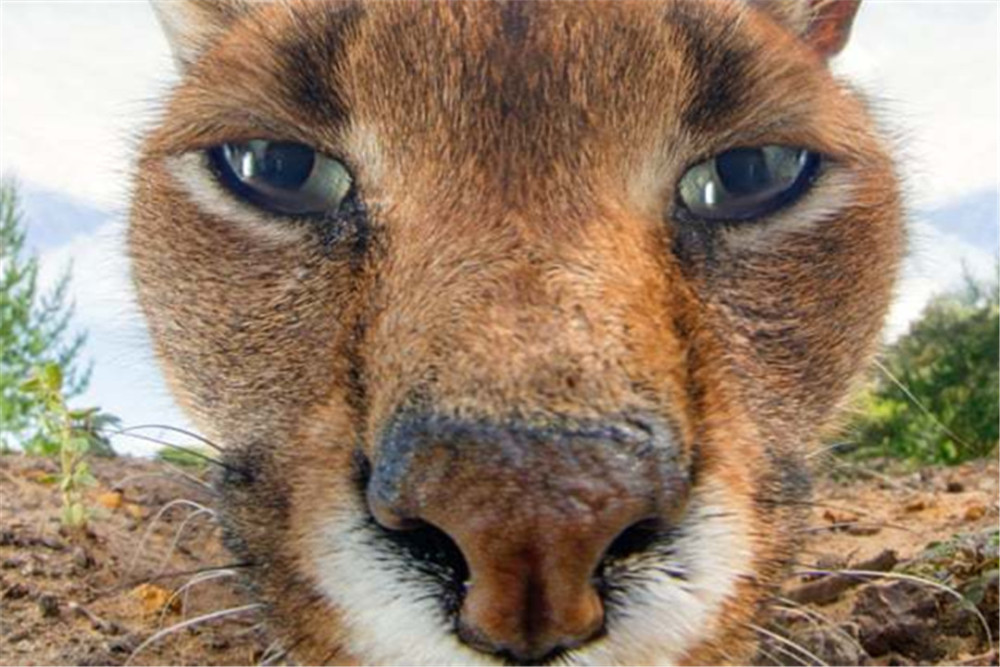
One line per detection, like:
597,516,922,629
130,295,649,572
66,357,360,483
0,0,1000,460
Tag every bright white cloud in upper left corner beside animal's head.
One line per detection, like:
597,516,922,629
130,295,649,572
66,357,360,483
0,1,174,207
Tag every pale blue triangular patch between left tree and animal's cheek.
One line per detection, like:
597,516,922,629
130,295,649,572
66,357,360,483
18,182,114,251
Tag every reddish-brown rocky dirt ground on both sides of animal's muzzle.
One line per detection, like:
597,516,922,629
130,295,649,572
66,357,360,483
0,454,998,665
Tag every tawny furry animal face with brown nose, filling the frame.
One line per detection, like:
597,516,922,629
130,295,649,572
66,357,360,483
129,0,902,664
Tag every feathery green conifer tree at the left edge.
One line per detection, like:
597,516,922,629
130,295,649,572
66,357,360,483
0,181,92,454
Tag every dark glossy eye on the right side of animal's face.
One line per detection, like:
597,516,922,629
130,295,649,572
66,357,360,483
678,146,820,220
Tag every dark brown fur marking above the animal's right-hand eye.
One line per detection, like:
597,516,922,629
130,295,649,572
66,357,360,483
667,2,753,130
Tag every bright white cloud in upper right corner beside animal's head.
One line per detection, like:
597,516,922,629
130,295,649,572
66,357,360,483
835,1,1000,207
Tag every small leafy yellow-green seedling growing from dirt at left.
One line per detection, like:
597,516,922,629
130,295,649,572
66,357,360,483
20,362,118,529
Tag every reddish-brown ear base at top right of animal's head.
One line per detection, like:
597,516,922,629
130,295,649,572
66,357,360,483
752,0,861,58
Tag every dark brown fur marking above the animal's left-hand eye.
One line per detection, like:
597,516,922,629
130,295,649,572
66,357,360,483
278,3,365,124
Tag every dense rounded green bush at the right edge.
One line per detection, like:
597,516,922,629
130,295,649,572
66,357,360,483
851,272,1000,464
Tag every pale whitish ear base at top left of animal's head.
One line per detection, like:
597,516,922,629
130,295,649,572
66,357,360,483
153,0,247,70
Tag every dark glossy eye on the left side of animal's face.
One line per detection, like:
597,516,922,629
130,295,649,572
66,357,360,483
208,139,352,215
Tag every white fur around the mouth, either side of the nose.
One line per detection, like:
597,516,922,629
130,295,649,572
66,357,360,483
312,481,752,665
